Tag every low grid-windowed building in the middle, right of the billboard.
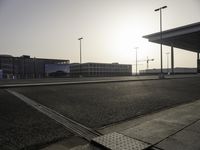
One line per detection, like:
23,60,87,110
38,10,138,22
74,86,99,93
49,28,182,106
70,63,132,77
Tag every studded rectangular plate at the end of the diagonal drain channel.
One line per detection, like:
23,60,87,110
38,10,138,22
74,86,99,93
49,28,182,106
92,132,151,150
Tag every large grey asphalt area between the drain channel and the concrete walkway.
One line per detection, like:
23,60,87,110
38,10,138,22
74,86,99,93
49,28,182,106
13,77,200,129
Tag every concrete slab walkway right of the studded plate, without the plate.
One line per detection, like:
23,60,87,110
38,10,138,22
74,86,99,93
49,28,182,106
99,100,200,150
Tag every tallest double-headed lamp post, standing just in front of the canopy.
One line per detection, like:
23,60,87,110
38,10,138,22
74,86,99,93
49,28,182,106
154,6,167,78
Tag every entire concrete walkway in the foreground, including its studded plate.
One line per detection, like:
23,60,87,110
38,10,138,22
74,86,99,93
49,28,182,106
44,100,200,150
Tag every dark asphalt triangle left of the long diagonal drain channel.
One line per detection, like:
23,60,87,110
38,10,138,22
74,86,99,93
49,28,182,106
0,90,73,150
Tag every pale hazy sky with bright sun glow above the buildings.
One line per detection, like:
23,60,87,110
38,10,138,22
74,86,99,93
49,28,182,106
0,0,200,69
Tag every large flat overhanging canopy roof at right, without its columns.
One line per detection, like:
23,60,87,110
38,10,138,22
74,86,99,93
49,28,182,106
143,22,200,52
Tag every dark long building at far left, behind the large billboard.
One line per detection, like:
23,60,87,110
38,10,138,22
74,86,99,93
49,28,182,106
0,55,70,79
